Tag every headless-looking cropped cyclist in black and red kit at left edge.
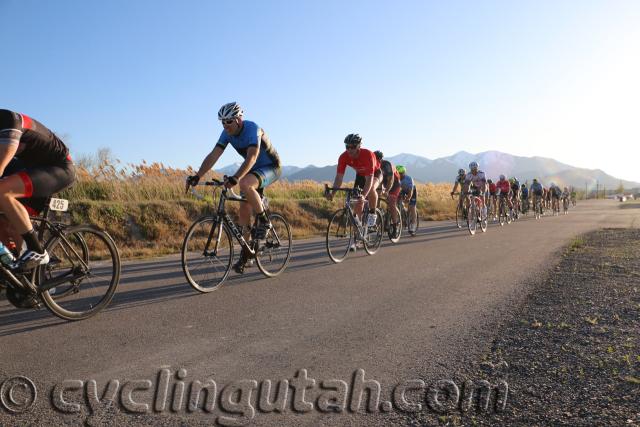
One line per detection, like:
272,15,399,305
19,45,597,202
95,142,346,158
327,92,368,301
0,109,75,271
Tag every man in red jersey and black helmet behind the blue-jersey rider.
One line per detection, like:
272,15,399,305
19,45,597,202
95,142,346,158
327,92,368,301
327,133,382,227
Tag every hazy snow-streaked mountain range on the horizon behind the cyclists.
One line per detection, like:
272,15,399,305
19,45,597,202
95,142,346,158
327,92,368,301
218,151,640,189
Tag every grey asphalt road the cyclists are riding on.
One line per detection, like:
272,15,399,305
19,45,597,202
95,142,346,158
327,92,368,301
0,201,640,425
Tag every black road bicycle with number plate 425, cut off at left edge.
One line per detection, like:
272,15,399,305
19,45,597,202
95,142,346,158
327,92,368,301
0,197,120,320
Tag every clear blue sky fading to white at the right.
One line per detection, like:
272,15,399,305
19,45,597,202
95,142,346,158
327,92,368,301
0,0,640,181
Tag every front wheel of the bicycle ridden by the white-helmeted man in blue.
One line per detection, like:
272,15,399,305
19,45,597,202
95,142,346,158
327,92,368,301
182,216,233,293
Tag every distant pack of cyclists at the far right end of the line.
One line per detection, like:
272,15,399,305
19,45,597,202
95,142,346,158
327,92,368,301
451,165,576,224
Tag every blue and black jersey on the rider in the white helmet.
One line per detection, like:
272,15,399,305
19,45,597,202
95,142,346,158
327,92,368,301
216,120,280,169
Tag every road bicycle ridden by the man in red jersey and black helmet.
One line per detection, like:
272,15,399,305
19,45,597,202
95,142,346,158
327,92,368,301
324,184,384,263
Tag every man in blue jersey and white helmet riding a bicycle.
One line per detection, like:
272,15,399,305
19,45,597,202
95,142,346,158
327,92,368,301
187,102,281,273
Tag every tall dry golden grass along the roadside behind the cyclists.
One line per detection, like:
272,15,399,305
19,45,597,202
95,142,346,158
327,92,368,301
60,158,455,256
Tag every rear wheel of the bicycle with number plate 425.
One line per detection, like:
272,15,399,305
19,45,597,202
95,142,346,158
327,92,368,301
37,225,120,320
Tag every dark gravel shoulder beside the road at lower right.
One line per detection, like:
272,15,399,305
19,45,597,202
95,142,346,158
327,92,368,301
405,228,640,426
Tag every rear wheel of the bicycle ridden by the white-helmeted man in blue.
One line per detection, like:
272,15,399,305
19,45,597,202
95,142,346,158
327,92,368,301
254,214,292,277
